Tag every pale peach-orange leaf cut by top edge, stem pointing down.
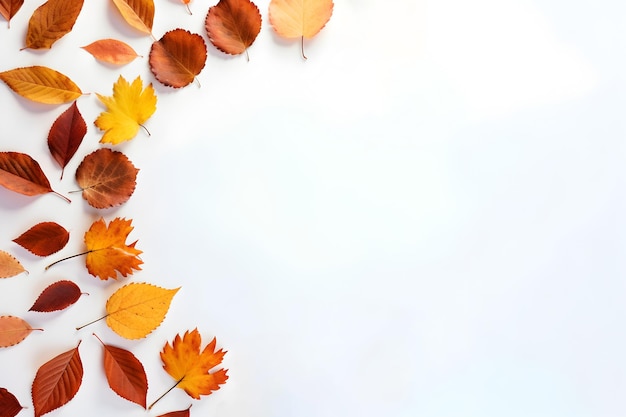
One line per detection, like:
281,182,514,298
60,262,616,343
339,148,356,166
269,0,333,59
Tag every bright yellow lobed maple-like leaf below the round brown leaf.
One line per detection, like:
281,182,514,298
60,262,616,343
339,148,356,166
95,75,157,145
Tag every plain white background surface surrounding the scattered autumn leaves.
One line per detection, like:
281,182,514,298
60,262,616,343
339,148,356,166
0,0,626,417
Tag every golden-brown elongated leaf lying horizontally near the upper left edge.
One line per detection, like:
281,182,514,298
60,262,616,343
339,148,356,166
0,65,83,104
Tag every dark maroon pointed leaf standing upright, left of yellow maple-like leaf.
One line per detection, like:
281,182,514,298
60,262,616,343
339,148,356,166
48,102,87,179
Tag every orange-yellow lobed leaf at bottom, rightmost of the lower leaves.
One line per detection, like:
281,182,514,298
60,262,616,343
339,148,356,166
148,329,228,409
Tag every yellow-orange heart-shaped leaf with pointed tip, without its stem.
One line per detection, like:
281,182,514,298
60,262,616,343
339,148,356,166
106,283,180,339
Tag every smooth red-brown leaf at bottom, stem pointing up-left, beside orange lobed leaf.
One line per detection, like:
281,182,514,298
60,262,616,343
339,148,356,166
94,334,148,408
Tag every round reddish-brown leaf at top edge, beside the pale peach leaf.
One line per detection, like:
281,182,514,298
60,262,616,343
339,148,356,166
205,0,261,56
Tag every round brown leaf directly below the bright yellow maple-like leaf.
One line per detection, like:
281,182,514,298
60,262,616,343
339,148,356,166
76,148,139,209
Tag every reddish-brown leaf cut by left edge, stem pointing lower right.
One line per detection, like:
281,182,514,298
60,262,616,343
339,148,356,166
0,152,69,202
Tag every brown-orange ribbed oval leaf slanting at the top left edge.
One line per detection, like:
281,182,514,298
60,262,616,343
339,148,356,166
25,0,84,49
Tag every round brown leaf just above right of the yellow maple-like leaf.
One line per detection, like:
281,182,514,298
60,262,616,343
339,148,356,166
149,29,207,88
